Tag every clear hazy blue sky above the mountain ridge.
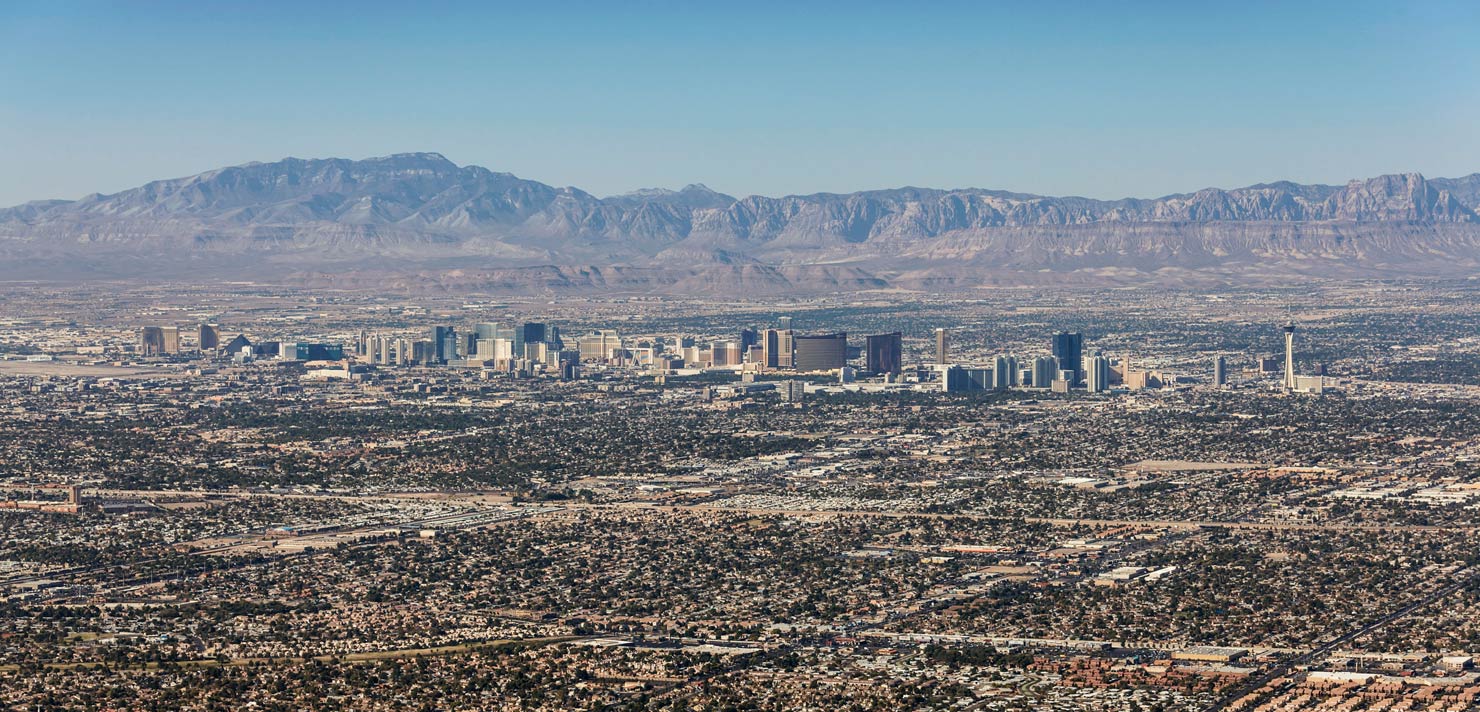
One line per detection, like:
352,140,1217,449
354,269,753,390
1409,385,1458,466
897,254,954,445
0,0,1480,206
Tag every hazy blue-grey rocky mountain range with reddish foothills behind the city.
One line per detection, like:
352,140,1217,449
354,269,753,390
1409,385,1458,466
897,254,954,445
0,152,1480,293
